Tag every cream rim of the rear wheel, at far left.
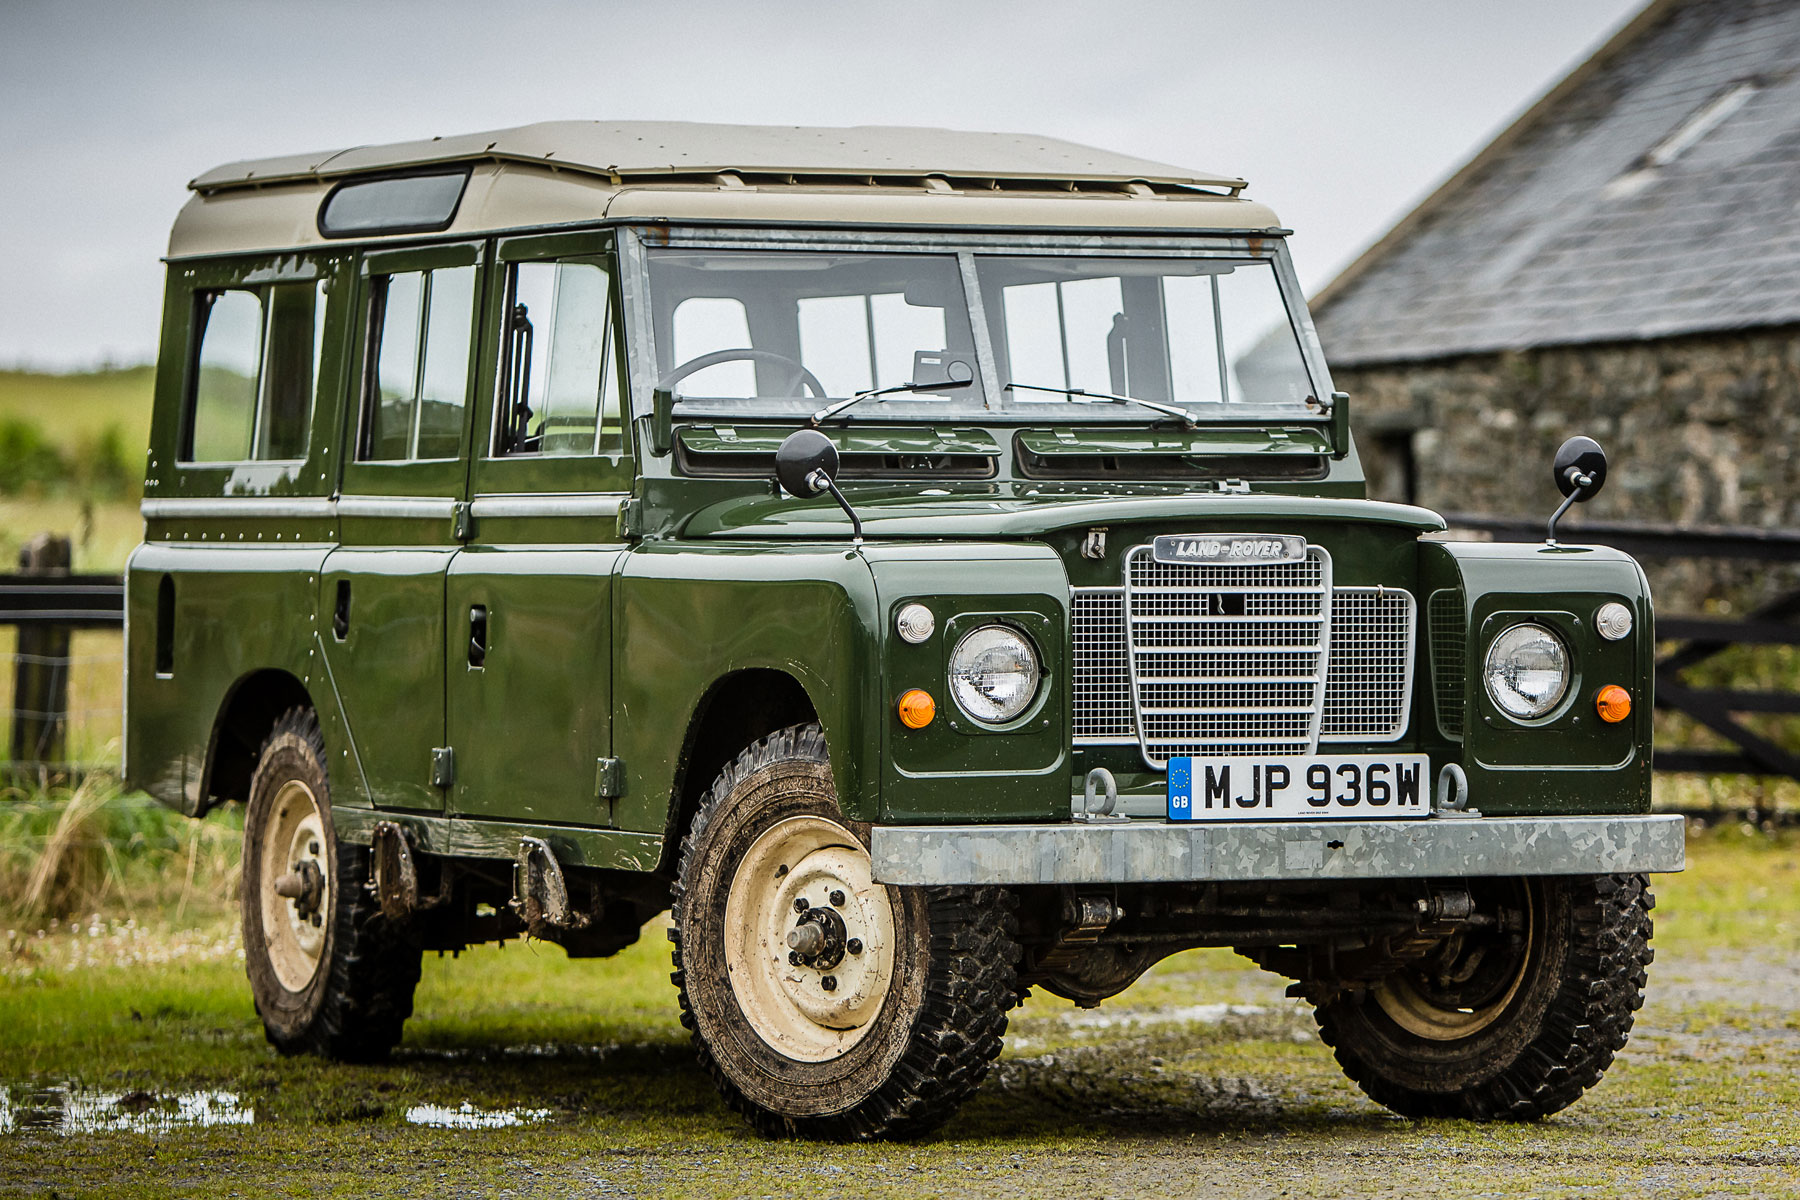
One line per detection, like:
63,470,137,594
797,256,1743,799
259,779,333,991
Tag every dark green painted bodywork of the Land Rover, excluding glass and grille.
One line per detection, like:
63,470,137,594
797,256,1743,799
126,211,1652,888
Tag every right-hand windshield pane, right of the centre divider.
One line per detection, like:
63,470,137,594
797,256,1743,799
976,255,1314,417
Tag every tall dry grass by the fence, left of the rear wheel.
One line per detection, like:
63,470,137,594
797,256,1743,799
0,775,243,927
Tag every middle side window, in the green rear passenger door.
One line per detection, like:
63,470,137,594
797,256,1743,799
356,266,475,462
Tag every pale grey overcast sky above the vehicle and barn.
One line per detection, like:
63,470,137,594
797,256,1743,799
0,0,1638,367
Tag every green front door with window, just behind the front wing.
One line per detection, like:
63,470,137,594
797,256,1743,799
443,232,632,826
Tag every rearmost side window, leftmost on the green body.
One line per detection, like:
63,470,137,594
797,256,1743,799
180,281,326,462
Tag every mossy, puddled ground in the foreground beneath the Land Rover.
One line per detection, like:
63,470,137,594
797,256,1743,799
0,801,1800,1198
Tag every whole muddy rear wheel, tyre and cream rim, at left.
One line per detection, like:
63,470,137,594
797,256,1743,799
239,709,421,1061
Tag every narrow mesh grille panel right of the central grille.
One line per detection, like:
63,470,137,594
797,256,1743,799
1319,588,1413,741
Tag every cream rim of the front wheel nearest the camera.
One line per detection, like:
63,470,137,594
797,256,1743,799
725,817,895,1063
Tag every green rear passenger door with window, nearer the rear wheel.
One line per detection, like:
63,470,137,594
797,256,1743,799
319,243,486,811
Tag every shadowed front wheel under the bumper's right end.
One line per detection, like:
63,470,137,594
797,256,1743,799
1316,874,1654,1121
